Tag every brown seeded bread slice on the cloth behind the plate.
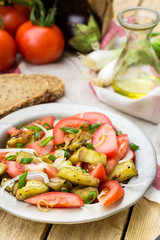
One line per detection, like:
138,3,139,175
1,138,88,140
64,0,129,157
0,74,64,118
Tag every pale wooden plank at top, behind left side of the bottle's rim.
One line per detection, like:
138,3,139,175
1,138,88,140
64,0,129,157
113,0,141,20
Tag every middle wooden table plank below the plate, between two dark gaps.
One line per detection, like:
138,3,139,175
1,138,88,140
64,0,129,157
47,209,129,240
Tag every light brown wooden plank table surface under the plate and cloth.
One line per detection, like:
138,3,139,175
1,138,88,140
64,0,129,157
0,0,160,240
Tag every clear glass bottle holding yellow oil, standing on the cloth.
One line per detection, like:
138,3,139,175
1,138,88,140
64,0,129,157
113,7,160,99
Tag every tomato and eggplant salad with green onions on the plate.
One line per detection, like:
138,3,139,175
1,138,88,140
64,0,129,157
0,112,139,211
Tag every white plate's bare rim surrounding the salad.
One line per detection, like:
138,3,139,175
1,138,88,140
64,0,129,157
0,103,157,224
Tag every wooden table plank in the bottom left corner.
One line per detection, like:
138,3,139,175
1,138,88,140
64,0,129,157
0,213,49,240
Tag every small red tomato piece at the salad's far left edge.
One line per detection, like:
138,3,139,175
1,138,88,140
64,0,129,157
6,161,25,178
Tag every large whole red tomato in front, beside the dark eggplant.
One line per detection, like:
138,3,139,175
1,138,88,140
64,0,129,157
16,21,65,64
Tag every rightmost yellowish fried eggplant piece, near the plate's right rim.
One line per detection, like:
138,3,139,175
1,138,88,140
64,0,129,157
107,160,138,182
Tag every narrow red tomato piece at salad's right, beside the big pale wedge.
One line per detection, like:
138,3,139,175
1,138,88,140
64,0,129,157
117,134,128,160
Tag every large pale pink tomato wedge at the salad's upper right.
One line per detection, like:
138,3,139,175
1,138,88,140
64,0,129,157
92,123,118,158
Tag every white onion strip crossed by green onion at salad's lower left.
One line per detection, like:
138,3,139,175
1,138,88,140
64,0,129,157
0,171,49,197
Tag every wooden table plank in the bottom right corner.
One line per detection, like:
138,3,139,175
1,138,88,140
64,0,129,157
125,198,160,240
